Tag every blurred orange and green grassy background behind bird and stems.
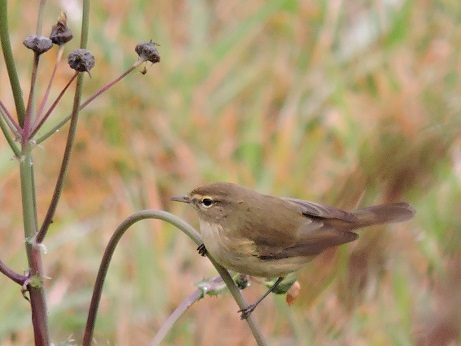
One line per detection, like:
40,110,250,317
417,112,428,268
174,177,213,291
0,0,461,345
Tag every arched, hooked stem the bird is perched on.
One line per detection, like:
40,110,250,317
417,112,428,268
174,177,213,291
82,210,266,346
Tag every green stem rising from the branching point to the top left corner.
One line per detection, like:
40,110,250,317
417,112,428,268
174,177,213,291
0,0,26,127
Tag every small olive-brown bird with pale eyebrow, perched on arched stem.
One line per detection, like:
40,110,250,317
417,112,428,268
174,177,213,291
172,182,415,319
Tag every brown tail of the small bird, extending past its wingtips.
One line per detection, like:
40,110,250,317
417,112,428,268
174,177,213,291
352,203,416,228
